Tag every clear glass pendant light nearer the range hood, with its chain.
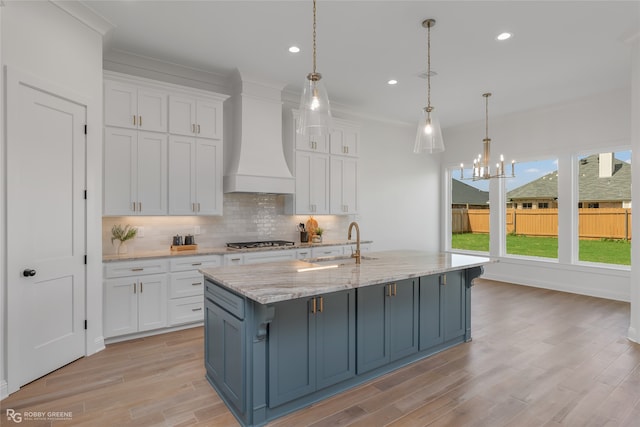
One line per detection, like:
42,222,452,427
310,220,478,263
296,0,331,135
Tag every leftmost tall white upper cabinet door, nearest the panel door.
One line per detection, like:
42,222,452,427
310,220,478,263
103,128,138,215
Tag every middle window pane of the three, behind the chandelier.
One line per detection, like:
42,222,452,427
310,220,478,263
506,159,558,258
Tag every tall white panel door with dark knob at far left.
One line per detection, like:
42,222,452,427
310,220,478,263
6,70,86,391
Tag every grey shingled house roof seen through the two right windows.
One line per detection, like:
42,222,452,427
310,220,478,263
507,154,631,201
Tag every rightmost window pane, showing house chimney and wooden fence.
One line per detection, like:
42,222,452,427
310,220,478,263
578,151,631,265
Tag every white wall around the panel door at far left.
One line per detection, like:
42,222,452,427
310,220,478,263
0,1,104,397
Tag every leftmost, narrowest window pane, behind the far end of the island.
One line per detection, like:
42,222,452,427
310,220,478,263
451,169,490,252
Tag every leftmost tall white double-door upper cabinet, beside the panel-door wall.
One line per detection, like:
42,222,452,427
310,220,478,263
103,128,167,216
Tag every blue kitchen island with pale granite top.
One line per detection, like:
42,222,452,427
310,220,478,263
202,251,491,426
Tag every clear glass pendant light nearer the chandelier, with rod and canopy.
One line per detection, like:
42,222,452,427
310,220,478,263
413,19,444,153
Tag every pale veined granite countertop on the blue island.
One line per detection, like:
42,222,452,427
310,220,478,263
200,250,494,304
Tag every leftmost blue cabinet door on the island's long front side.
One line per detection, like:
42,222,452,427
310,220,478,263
269,298,316,408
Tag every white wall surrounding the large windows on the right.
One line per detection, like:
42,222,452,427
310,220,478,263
443,88,640,301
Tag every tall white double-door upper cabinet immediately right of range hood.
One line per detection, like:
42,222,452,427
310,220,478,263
295,151,330,215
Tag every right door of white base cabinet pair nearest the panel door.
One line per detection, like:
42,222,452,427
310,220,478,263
138,274,167,332
